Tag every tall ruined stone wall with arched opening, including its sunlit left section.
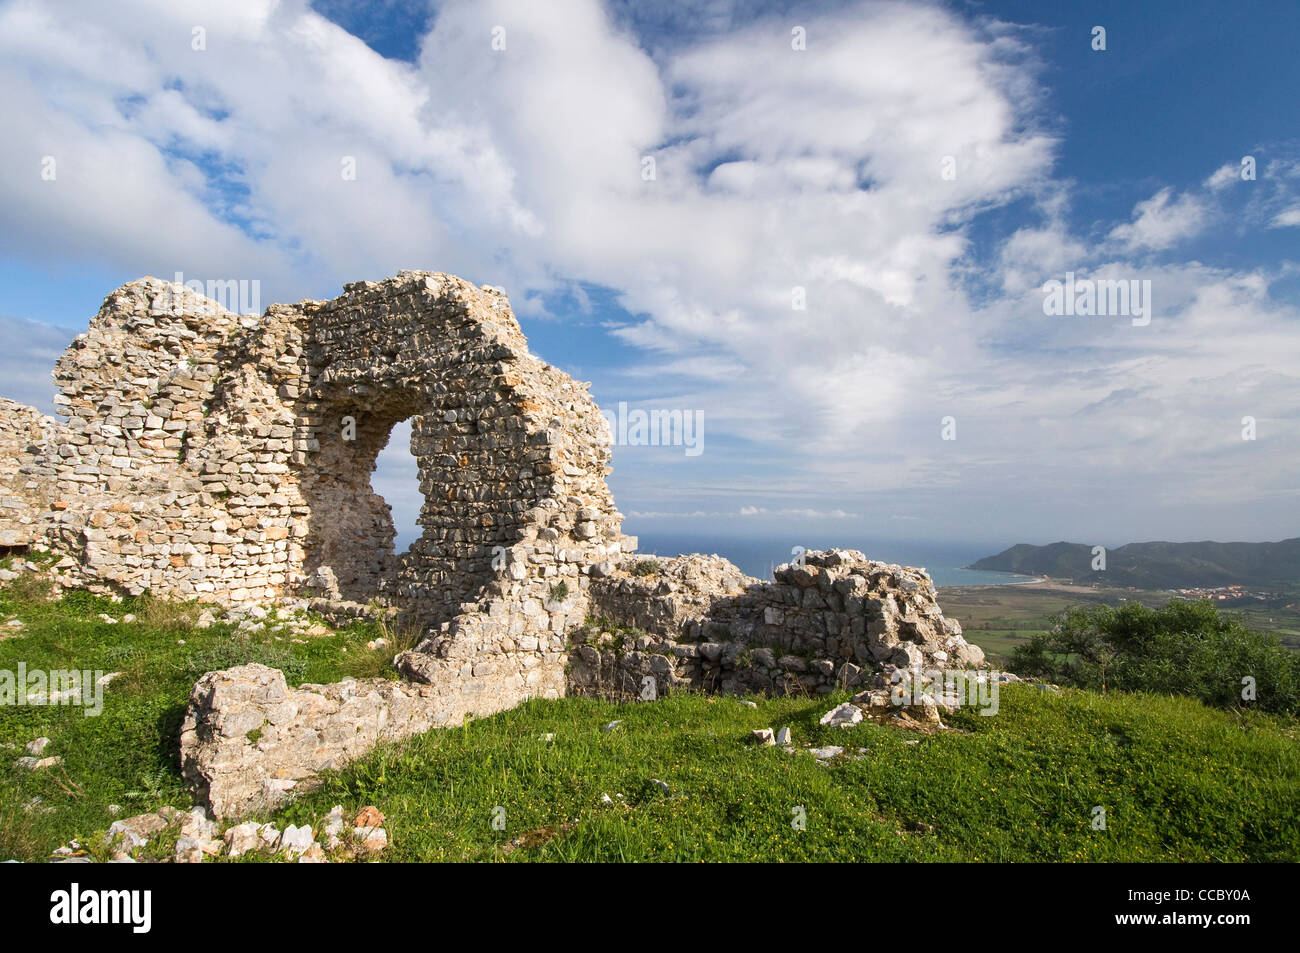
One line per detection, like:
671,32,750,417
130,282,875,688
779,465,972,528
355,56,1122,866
35,272,623,692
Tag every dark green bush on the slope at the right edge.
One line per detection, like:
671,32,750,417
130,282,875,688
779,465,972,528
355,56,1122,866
1011,599,1300,712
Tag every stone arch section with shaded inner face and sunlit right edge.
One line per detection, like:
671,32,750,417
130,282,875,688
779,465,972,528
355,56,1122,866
280,273,621,625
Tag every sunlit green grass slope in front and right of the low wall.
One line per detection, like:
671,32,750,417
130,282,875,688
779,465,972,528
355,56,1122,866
269,686,1300,862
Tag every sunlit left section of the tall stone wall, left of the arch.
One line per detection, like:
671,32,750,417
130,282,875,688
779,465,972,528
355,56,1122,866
43,278,245,599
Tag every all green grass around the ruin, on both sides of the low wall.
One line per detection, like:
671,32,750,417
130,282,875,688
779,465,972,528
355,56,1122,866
0,556,1300,862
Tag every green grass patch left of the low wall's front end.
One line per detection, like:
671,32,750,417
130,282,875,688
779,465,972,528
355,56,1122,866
0,556,402,859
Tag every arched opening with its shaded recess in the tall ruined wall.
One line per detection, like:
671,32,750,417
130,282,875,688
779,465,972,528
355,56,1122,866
300,381,537,625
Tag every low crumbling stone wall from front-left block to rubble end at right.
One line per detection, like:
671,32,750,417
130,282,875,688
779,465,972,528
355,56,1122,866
181,550,984,816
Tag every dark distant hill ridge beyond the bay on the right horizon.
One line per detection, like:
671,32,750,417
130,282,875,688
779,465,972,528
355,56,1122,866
966,537,1300,589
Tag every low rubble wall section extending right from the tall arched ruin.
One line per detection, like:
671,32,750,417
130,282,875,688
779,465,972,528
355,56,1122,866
569,550,984,696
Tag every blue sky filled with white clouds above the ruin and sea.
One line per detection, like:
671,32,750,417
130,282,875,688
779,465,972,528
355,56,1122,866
0,0,1300,551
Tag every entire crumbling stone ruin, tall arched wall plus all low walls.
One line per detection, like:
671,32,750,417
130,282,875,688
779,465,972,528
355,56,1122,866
0,272,983,816
